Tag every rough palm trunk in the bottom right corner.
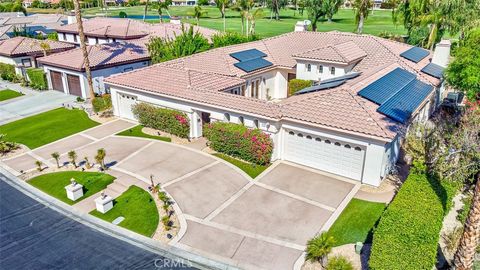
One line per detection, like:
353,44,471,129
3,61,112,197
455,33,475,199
453,176,480,270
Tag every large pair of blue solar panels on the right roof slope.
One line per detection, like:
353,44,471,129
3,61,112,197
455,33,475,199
358,68,433,123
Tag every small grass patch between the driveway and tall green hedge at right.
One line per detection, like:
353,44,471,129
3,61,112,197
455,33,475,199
328,198,386,246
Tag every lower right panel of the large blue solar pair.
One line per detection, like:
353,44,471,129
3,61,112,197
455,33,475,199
377,79,433,123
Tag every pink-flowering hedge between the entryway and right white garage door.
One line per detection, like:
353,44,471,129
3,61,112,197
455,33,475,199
203,122,273,165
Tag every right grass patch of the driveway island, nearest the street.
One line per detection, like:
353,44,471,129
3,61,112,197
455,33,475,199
90,186,159,237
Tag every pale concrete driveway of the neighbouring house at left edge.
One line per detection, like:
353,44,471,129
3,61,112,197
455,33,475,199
0,80,76,125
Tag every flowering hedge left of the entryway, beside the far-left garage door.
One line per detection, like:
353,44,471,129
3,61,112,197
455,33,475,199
132,103,190,138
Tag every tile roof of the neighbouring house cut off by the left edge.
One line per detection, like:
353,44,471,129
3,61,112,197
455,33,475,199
0,37,75,57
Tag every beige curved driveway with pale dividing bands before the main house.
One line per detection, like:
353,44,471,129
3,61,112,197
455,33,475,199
0,120,359,269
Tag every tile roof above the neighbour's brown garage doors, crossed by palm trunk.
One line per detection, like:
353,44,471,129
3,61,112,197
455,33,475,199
38,40,150,71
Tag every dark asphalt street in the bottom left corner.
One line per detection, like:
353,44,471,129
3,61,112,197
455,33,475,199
0,174,188,269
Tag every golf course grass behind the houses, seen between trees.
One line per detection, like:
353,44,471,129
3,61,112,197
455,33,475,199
29,6,406,37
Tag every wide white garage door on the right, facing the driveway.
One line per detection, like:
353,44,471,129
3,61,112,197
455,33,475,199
284,130,365,180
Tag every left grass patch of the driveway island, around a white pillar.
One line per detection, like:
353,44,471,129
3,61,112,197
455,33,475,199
27,171,115,205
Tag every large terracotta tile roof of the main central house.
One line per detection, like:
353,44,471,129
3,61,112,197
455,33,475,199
106,31,440,141
